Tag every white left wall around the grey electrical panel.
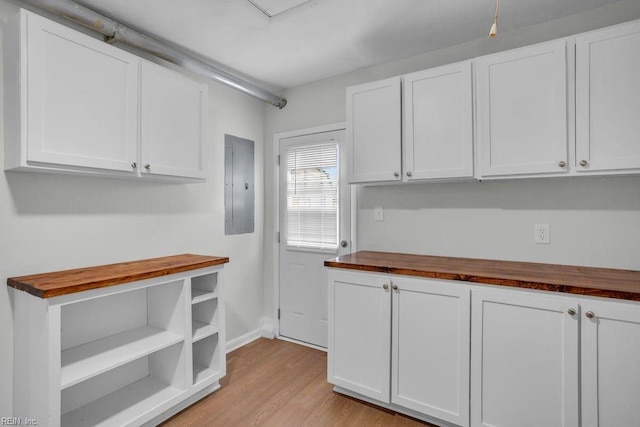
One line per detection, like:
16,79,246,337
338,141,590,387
0,1,266,417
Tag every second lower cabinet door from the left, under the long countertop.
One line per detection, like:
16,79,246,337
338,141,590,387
391,277,471,426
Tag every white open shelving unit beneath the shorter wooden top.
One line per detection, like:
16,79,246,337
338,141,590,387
13,265,226,427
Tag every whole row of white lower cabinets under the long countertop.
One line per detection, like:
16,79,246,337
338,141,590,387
328,268,640,427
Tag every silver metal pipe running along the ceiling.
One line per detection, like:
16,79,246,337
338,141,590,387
20,0,287,108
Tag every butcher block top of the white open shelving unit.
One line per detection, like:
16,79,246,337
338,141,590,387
7,254,229,298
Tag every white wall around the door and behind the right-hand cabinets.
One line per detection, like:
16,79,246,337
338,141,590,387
265,0,640,314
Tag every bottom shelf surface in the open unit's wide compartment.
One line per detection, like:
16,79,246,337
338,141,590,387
61,376,183,427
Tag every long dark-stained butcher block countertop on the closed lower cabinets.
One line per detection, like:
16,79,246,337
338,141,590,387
324,251,640,301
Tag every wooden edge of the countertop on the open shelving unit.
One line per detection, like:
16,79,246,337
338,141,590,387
7,257,229,298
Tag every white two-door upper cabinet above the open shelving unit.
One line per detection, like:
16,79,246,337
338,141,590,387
3,10,208,181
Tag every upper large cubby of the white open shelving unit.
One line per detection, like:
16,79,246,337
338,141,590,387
60,281,185,390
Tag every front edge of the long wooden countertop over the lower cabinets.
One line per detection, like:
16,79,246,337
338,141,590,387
324,260,640,301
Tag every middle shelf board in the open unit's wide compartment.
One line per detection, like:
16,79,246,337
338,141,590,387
60,326,184,390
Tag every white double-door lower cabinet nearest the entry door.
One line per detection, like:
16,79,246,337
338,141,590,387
328,270,469,426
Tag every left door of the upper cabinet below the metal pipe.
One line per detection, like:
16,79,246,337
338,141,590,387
21,12,139,173
